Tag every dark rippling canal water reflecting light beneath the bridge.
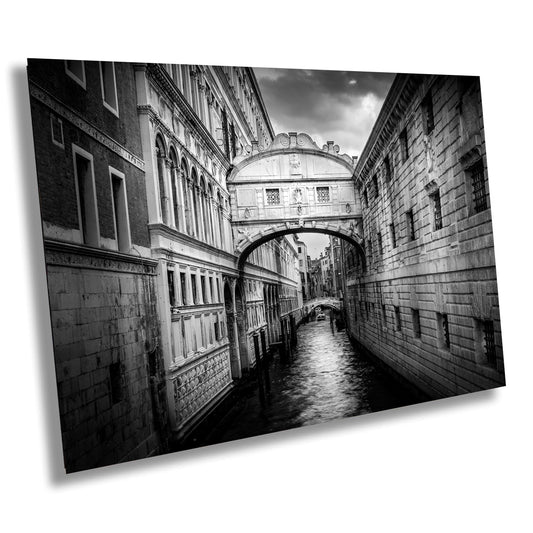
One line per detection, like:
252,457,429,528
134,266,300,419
203,320,416,444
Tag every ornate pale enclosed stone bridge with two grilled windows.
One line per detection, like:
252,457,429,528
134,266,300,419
227,132,364,268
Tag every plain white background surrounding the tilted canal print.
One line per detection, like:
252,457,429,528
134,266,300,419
0,0,533,533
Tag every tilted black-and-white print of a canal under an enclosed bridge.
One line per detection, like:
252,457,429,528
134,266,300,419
28,59,505,472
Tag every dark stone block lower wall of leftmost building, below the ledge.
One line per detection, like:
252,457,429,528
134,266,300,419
46,243,166,472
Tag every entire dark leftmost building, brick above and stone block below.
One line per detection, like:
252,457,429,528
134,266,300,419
28,60,167,472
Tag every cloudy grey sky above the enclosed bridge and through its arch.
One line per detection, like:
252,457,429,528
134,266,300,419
254,68,394,258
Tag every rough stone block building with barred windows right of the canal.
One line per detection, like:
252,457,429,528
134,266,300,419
343,75,505,398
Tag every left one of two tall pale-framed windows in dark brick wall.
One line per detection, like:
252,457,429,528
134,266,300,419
72,144,100,246
